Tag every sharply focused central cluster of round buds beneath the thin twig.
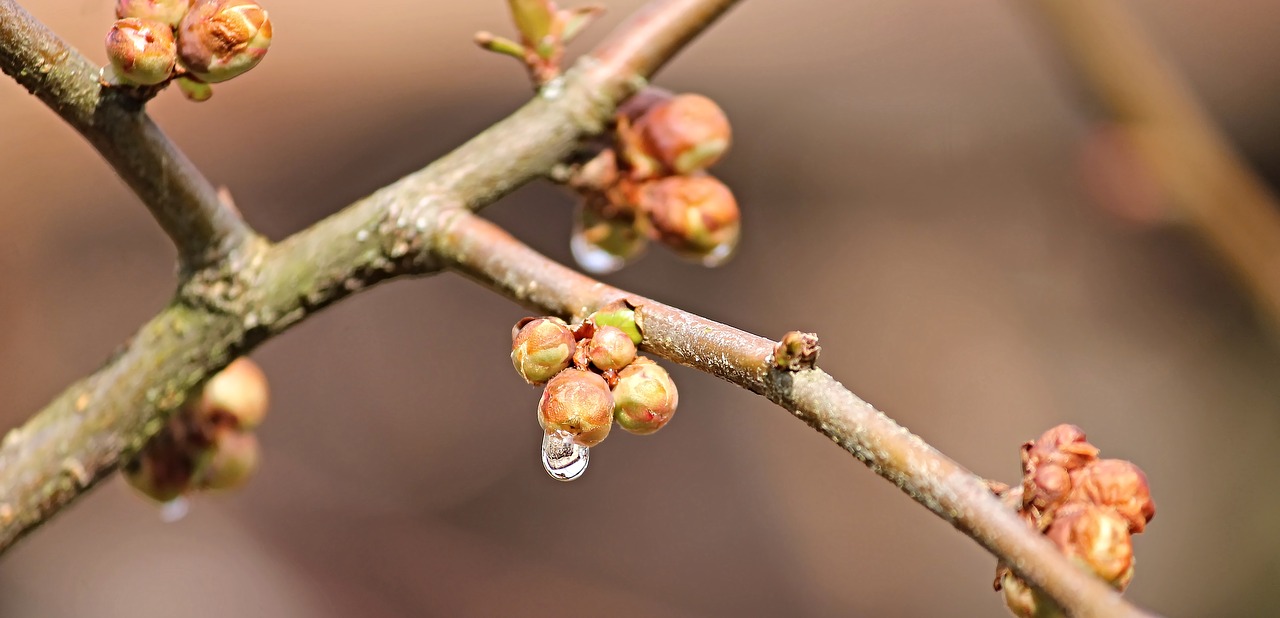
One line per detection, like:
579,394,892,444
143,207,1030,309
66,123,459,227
511,302,678,478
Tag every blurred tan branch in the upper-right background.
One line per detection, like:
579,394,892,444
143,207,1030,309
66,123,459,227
1028,0,1280,335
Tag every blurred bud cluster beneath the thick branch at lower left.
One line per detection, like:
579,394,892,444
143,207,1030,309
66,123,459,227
124,358,268,503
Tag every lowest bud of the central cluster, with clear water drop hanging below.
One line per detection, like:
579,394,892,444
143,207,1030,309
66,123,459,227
538,368,613,447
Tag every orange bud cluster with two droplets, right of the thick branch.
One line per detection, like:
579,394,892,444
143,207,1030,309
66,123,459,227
570,88,741,273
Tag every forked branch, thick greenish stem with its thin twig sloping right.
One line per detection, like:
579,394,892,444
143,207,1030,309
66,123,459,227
0,0,1143,617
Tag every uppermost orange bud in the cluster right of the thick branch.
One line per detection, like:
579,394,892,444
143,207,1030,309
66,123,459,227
620,95,731,178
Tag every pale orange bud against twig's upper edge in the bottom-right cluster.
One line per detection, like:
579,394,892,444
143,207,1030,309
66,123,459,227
1044,503,1133,590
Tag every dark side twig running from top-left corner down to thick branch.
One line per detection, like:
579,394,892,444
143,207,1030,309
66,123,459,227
0,0,252,273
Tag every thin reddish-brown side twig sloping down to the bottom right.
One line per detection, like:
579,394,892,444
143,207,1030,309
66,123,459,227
435,209,1148,617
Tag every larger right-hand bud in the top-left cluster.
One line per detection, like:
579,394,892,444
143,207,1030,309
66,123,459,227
178,0,271,83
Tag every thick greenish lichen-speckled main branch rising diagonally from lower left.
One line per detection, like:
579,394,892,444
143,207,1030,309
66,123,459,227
0,0,735,551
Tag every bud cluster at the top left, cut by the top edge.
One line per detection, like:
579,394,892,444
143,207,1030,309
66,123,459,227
101,0,271,101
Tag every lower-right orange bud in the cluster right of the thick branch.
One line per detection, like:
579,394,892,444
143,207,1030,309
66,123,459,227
636,175,741,266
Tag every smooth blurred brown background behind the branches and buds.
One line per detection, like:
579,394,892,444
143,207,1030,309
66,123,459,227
0,0,1280,618
